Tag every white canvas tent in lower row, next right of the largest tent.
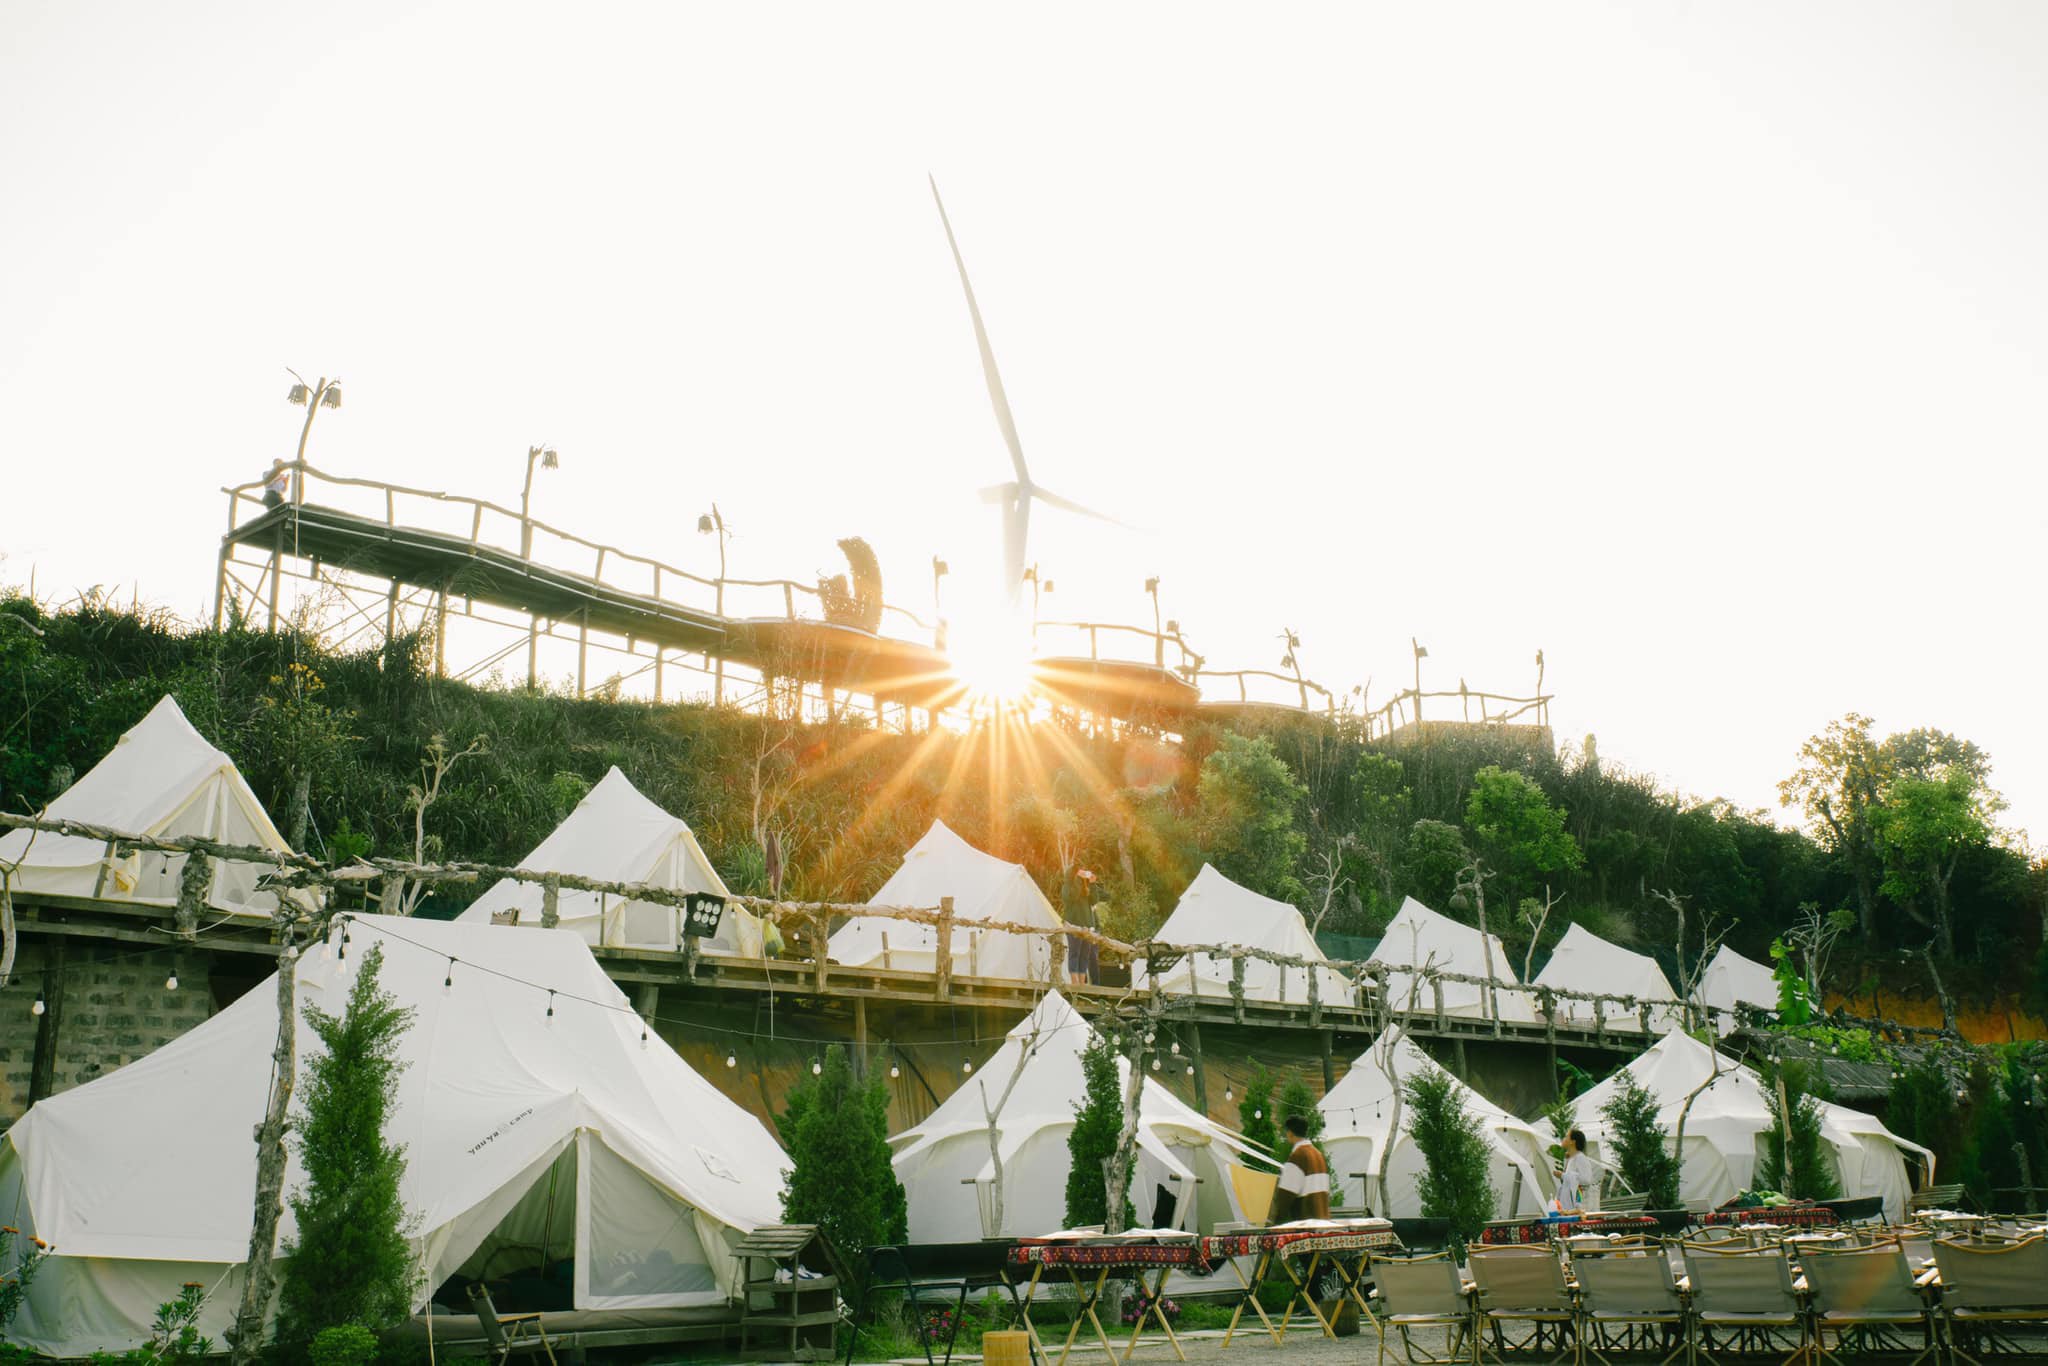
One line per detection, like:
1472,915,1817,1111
889,991,1266,1243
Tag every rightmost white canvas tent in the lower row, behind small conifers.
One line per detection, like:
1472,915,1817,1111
1577,1030,1933,1223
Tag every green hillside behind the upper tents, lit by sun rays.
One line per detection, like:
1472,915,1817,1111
0,598,2044,993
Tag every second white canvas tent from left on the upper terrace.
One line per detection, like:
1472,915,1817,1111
459,768,762,958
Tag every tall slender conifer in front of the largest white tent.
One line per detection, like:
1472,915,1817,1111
276,944,414,1360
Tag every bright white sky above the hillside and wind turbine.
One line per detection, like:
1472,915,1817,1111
0,0,2048,831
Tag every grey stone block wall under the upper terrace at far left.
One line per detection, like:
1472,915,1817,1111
0,938,215,1124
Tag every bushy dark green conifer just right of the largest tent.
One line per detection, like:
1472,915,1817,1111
778,1044,909,1266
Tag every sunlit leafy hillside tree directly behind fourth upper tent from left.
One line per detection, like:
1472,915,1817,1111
1196,733,1309,903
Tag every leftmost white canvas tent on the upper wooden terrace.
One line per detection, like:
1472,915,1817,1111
0,696,303,917
